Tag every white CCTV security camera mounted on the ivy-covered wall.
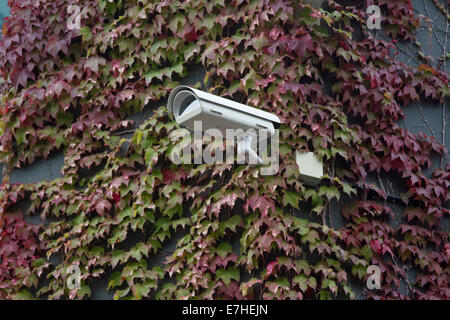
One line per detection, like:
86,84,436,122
168,86,280,163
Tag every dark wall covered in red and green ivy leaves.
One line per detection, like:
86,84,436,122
0,1,449,299
